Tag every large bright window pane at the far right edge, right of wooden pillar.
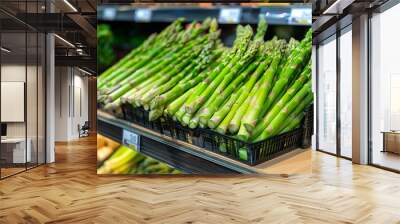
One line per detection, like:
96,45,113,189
371,5,400,170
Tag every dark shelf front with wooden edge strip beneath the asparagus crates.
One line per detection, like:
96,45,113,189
97,111,304,174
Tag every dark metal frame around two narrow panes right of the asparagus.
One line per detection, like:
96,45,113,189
314,17,352,160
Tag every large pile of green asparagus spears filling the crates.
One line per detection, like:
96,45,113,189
98,19,313,142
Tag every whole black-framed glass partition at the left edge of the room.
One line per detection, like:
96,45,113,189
0,0,46,178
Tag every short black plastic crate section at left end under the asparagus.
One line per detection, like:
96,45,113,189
121,104,164,134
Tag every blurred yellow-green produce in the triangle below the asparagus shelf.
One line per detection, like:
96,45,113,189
97,135,182,174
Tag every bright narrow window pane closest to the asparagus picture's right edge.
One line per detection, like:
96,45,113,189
318,37,337,153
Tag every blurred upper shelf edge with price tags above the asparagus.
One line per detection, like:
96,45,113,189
97,5,311,26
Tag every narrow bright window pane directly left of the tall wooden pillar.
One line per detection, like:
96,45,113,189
340,29,353,158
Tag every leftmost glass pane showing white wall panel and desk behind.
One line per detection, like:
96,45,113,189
1,32,27,177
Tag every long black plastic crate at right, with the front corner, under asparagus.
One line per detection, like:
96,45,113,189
166,106,313,165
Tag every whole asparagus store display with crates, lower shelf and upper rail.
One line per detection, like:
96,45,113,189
97,5,313,173
